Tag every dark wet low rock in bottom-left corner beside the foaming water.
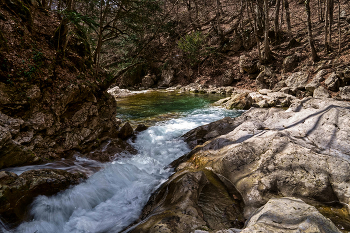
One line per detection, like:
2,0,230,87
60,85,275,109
0,169,86,225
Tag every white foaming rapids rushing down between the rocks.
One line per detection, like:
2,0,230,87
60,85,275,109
14,108,239,233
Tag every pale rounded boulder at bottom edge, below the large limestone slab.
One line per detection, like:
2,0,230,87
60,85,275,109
241,197,341,233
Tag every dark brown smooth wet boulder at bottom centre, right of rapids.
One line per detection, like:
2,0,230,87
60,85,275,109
129,170,244,232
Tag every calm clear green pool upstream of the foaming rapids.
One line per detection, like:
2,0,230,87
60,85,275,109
117,91,225,125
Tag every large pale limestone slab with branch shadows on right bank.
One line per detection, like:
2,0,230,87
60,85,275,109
179,98,350,217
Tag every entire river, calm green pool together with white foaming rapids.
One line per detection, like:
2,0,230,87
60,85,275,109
7,92,241,233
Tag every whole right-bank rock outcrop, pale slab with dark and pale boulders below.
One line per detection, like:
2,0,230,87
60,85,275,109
133,98,350,232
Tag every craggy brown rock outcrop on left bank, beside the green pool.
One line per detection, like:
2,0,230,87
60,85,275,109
0,83,119,169
